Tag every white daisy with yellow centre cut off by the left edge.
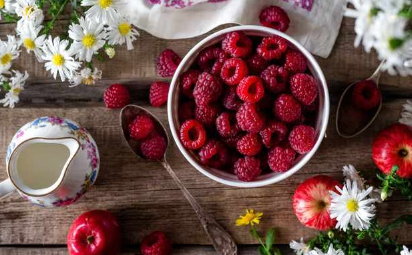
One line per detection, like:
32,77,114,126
0,35,20,74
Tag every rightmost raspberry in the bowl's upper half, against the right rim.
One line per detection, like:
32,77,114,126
290,73,318,105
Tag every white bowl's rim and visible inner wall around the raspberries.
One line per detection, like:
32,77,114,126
167,26,330,188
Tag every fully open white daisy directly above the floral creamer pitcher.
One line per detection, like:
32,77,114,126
42,36,81,81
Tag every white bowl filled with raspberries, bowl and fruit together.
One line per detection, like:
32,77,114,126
168,26,330,187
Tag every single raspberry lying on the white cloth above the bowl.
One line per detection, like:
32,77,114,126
259,5,290,32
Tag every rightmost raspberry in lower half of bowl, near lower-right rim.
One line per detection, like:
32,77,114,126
289,125,315,154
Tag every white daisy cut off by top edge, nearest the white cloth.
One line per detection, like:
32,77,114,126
82,0,127,24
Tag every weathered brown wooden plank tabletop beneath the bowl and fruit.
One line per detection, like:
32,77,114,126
0,16,412,255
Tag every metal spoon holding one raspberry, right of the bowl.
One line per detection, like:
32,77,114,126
336,60,385,138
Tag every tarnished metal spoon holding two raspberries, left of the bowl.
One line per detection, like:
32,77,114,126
120,105,237,255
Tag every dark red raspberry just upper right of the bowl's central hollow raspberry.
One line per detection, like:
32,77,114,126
260,65,289,94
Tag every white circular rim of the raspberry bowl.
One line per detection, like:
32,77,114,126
167,25,330,188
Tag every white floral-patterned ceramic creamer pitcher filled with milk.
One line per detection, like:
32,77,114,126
0,117,100,207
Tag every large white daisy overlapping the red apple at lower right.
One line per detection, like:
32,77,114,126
330,180,375,232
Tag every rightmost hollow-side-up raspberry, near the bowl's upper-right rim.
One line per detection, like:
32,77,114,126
256,35,288,61
